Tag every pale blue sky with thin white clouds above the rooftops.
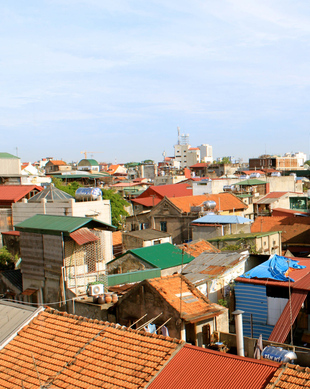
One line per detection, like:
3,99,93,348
0,0,310,163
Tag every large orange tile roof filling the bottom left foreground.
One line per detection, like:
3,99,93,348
0,309,182,389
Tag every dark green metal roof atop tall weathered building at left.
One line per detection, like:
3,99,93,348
15,215,116,235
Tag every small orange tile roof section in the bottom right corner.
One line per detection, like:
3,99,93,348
266,363,310,389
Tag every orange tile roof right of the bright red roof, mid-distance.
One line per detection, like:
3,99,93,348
169,193,247,212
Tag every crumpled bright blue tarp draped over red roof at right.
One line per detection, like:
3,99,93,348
241,254,306,282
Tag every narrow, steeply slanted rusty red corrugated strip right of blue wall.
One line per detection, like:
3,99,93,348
268,290,308,343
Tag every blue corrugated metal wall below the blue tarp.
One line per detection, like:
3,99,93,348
235,282,274,340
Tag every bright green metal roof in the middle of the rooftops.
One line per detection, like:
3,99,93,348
110,243,194,269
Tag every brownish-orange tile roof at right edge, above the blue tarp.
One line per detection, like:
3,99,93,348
251,216,310,243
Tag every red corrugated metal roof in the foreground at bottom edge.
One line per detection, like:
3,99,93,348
148,344,280,389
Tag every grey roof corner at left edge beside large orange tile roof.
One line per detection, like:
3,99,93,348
0,301,42,344
